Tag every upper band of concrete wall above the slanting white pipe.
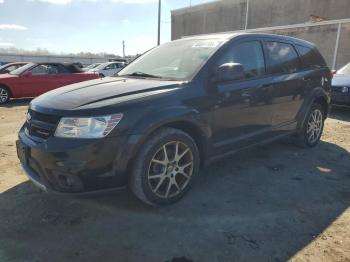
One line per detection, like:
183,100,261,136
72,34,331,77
171,0,350,39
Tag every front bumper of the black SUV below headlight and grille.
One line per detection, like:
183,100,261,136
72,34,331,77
17,128,138,194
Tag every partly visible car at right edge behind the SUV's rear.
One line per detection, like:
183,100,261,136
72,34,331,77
331,63,350,106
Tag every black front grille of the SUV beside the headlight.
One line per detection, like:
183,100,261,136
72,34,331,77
26,110,61,139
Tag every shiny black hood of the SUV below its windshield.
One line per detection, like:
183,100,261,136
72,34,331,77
31,77,183,111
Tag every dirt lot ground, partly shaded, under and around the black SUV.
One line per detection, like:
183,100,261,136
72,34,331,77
0,101,350,262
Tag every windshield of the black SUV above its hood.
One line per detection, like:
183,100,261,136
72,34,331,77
118,39,222,80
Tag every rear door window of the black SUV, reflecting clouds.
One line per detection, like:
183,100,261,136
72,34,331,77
266,41,299,74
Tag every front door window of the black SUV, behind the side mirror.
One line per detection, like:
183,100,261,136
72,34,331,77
217,41,265,78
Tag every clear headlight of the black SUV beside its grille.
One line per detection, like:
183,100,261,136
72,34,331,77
55,114,123,138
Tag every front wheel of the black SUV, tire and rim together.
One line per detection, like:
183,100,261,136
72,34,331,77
129,128,199,206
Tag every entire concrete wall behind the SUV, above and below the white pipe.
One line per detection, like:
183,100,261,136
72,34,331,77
171,0,350,69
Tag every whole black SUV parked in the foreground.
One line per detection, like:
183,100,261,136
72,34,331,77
17,33,332,205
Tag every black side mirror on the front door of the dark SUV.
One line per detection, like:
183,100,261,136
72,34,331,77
216,63,245,82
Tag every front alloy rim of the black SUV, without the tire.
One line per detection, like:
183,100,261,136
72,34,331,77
147,141,194,198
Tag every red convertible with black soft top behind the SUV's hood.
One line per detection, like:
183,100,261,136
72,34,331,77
0,63,99,104
